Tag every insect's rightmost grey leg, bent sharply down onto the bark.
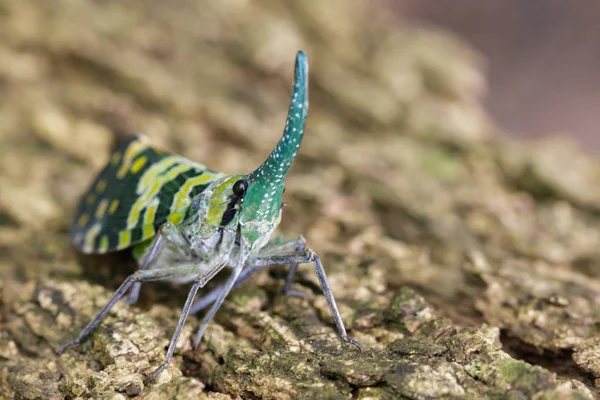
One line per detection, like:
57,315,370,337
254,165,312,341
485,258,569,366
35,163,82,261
249,249,363,351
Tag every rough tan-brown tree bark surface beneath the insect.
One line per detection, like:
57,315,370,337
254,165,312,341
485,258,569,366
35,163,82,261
0,0,600,399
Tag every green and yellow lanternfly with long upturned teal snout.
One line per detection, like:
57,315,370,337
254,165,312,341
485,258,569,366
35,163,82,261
60,52,362,378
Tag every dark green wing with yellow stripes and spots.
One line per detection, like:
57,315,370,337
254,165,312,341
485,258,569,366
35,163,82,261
71,136,224,253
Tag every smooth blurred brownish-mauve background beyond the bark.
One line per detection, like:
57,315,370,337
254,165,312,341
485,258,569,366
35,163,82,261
394,0,600,152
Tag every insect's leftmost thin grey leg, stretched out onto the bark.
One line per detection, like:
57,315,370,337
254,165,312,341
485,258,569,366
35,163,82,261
59,267,206,353
